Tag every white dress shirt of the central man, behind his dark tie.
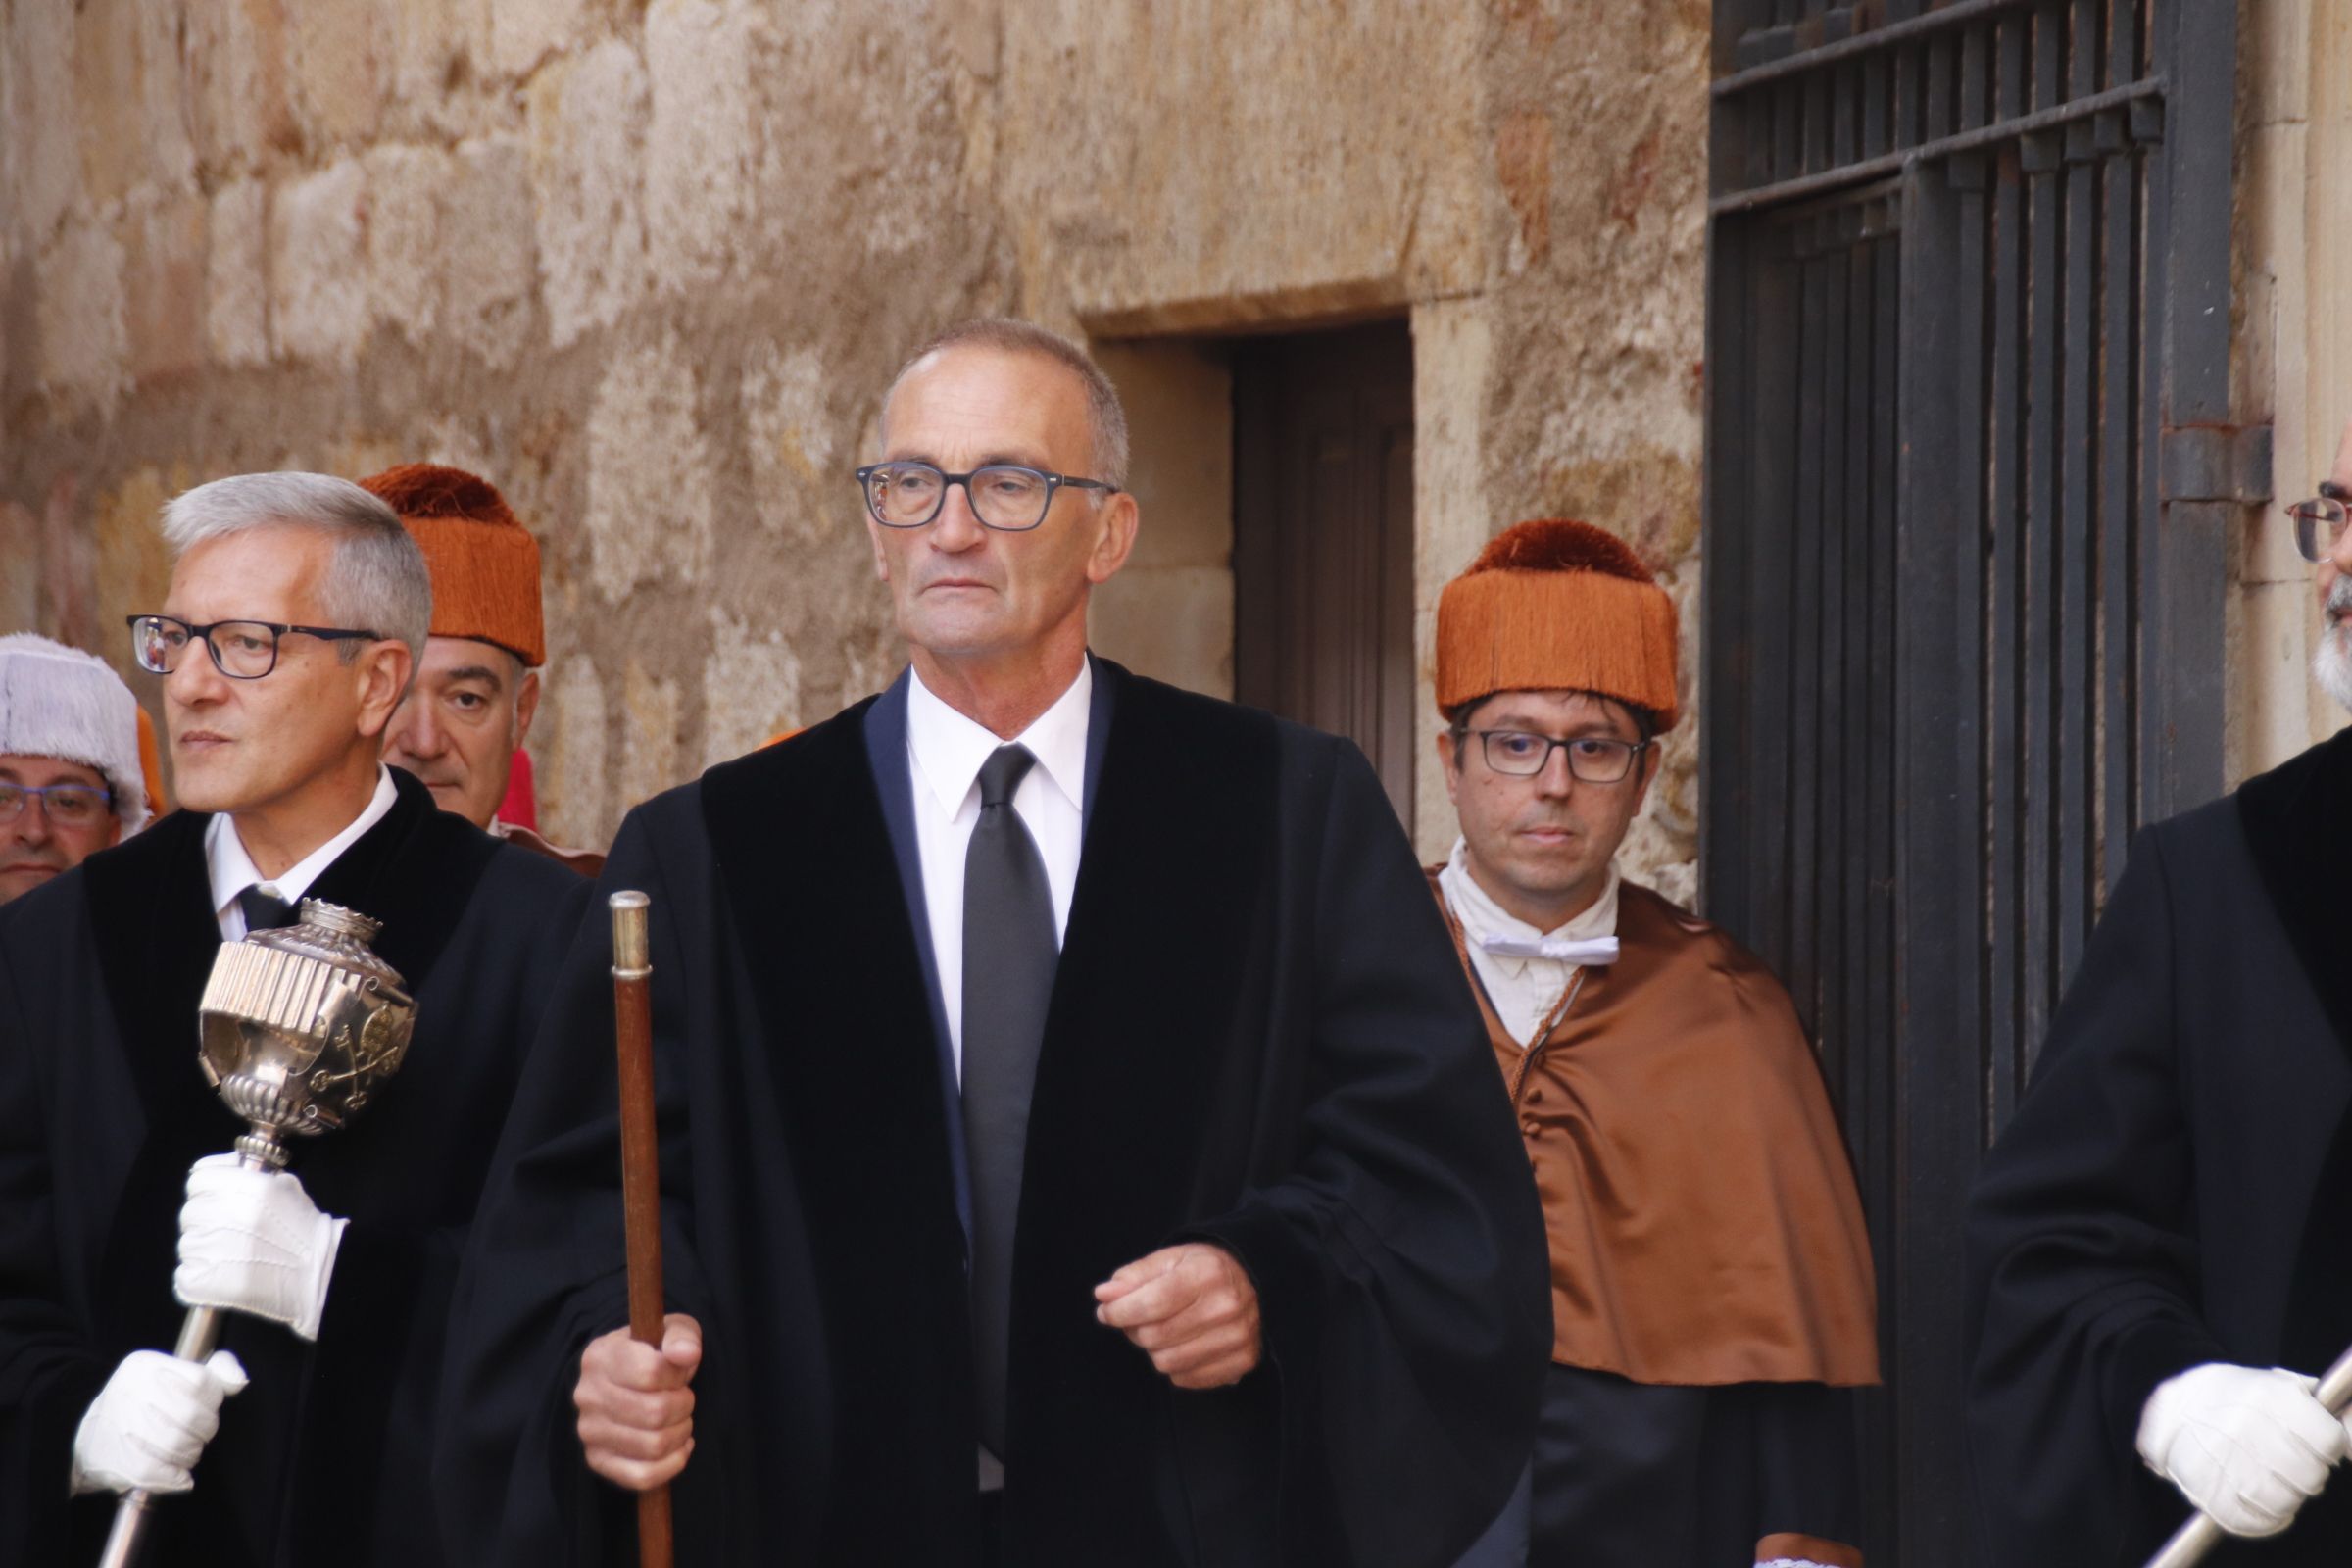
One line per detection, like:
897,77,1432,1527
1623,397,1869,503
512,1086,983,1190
906,662,1094,1081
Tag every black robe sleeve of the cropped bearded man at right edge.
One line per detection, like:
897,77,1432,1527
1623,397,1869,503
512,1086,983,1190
1966,832,2228,1563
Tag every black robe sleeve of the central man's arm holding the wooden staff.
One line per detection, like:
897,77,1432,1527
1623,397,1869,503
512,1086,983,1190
433,811,710,1568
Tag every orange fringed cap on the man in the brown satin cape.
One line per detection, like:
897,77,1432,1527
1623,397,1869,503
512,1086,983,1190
1437,517,1680,729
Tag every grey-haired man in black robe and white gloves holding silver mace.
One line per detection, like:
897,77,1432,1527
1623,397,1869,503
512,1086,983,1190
0,475,588,1568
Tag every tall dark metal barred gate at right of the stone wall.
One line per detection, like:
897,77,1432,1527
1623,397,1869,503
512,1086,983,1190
1700,0,2268,1568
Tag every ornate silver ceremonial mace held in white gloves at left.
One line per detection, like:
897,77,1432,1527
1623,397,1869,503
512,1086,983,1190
99,898,416,1568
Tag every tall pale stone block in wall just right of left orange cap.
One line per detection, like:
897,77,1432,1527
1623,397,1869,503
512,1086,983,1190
586,336,712,600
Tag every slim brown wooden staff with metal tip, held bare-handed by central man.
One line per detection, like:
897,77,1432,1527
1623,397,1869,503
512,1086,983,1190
607,894,670,1568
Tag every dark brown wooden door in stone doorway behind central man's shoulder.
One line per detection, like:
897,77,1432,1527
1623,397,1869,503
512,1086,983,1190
1233,322,1423,827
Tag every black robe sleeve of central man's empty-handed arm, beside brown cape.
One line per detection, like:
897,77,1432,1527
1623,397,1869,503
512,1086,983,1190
1186,743,1550,1566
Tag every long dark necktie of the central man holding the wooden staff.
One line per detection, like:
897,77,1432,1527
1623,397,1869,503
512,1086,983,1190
964,745,1060,1457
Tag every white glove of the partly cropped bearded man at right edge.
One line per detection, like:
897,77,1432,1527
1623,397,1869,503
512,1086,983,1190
2138,1361,2345,1535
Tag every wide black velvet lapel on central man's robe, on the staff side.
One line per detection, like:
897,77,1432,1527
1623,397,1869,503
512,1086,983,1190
701,703,974,1563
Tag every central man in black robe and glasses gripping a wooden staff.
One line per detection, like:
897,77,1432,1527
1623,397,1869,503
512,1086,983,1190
440,322,1550,1568
